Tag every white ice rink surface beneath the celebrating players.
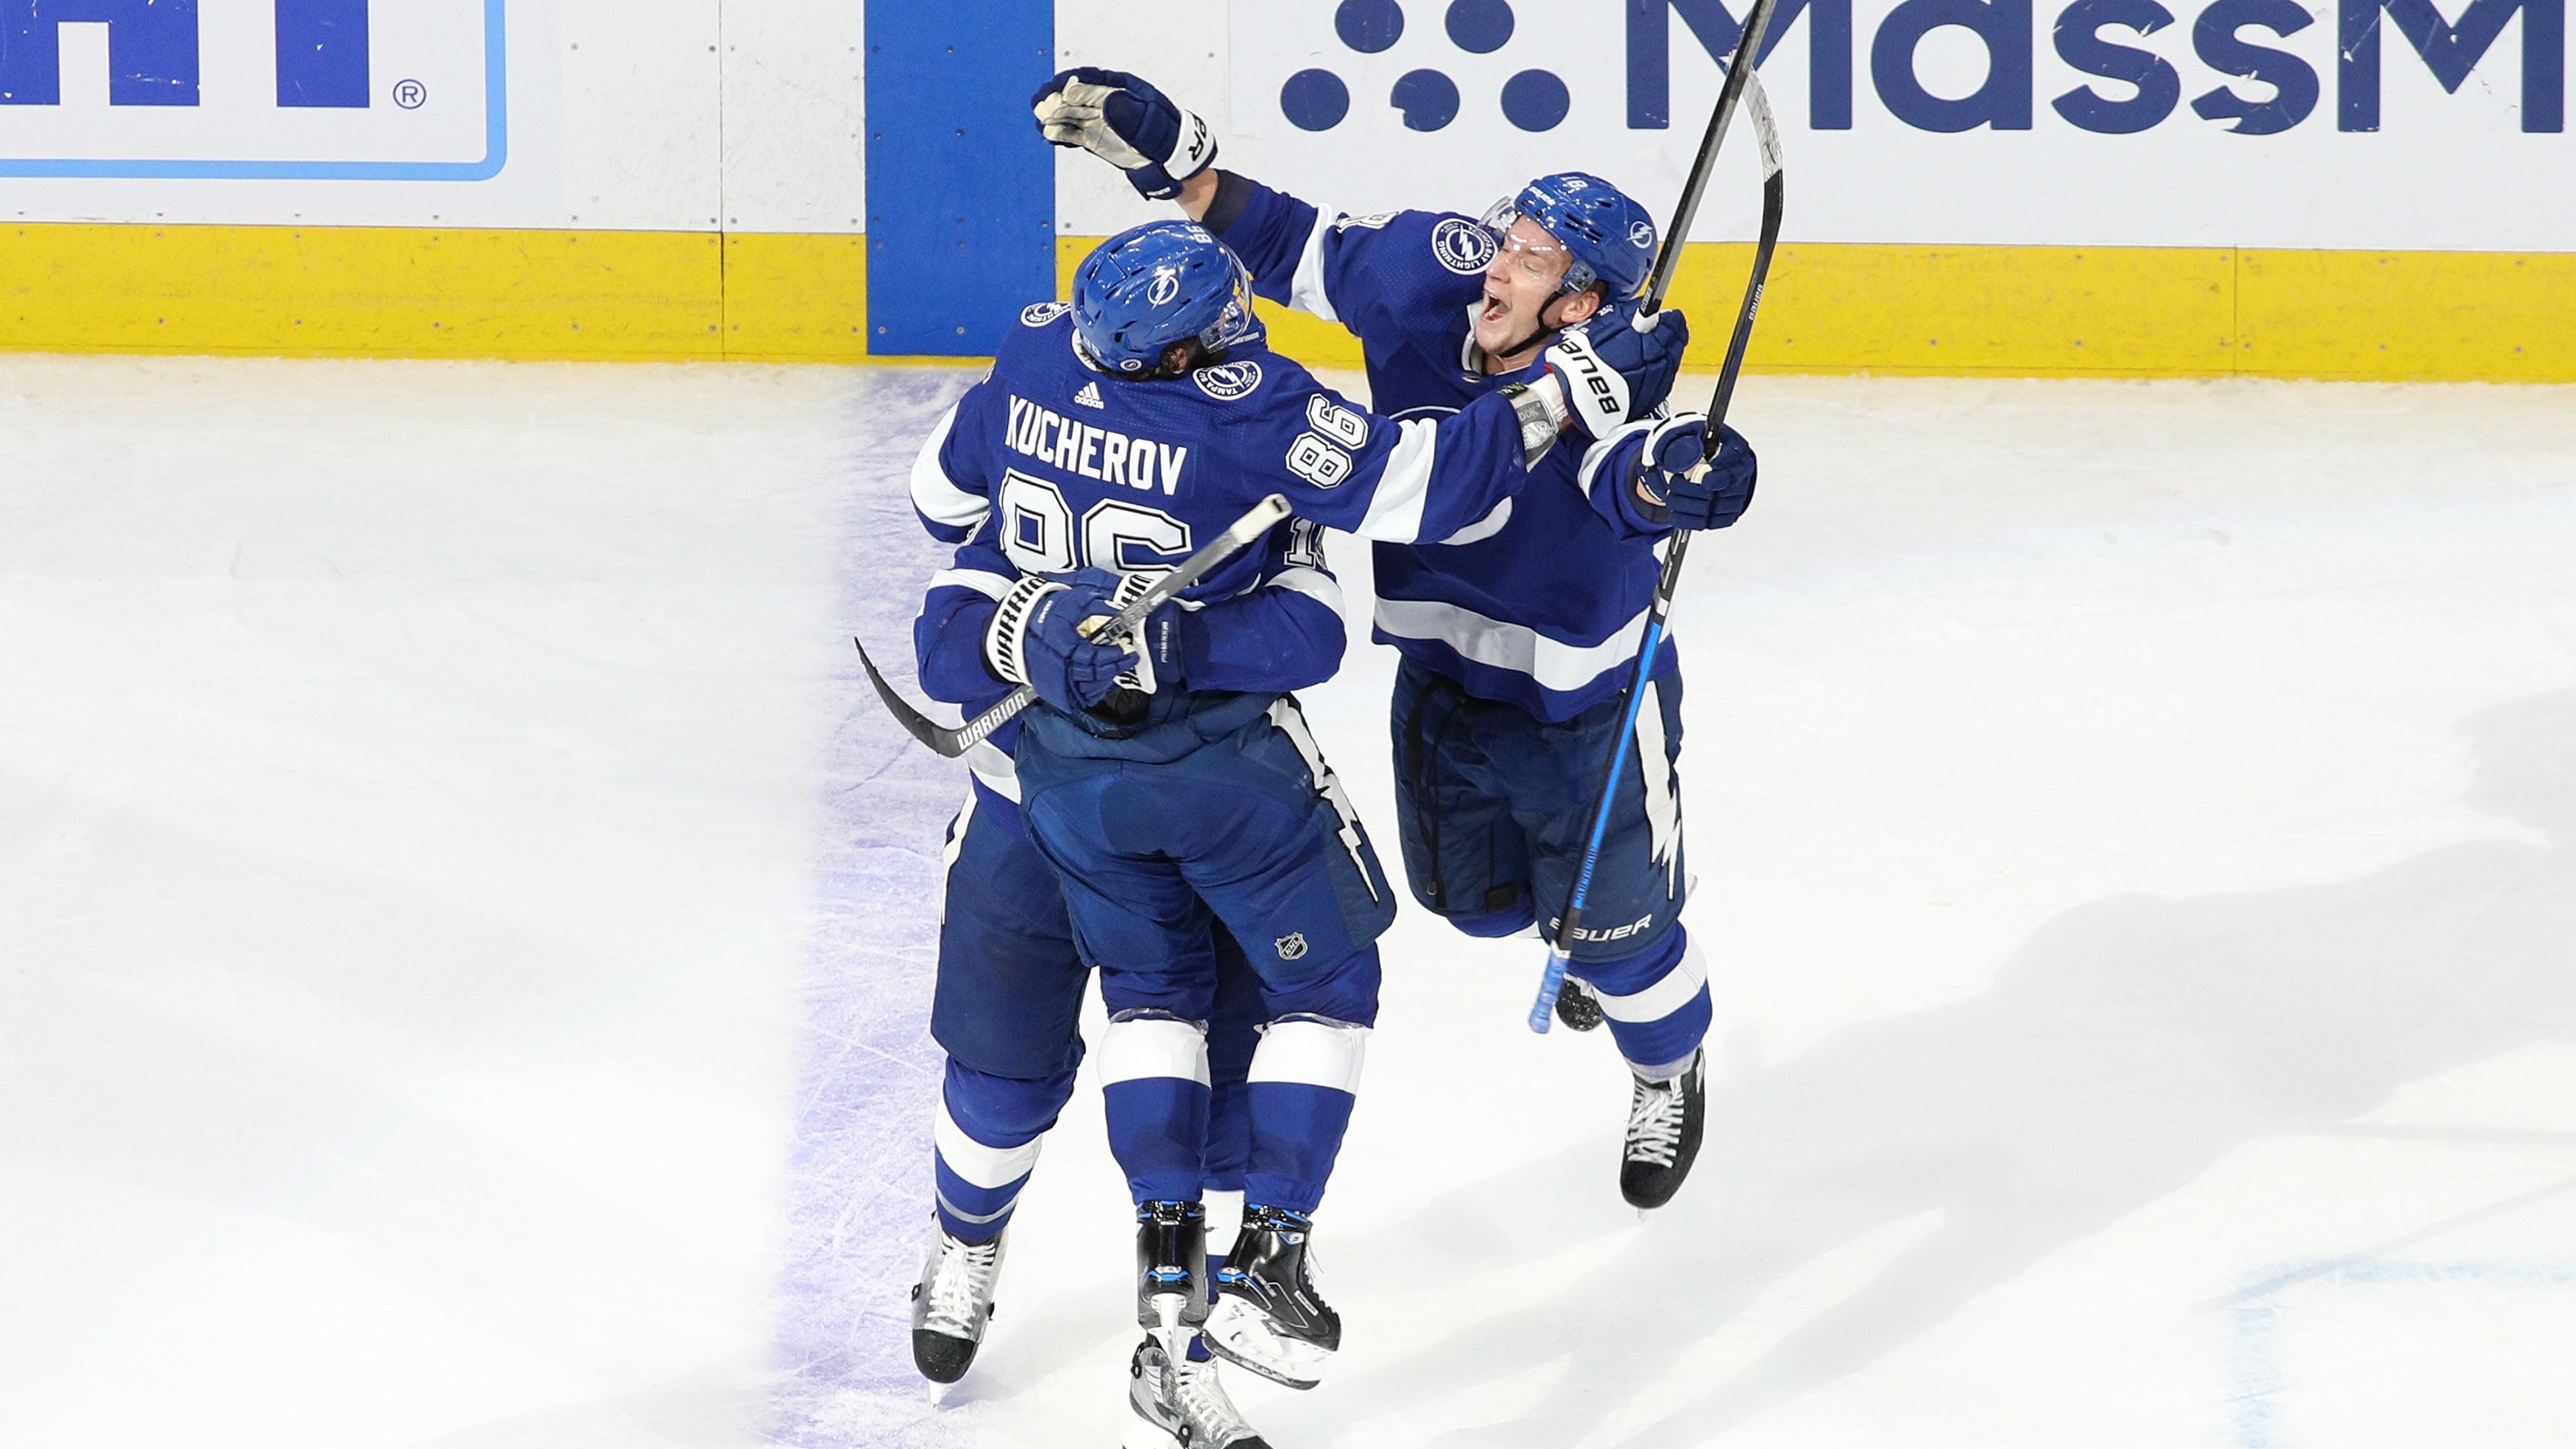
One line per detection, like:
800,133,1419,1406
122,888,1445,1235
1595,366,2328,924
0,358,2576,1449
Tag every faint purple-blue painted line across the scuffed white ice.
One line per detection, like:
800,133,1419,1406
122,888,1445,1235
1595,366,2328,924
770,368,974,1449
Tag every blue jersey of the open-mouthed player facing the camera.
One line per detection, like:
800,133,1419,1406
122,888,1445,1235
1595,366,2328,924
1221,178,1677,721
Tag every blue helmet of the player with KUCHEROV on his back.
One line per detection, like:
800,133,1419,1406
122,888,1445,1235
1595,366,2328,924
1074,221,1262,373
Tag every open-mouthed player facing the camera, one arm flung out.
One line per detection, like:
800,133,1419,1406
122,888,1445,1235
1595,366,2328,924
1033,70,1754,1207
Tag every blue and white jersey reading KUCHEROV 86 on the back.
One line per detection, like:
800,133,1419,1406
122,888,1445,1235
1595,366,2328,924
912,304,1530,797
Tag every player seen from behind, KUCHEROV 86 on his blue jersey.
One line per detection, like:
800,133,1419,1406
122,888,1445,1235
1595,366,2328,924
914,221,1680,1434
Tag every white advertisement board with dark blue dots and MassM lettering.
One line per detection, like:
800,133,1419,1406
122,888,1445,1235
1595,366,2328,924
1231,0,2576,252
